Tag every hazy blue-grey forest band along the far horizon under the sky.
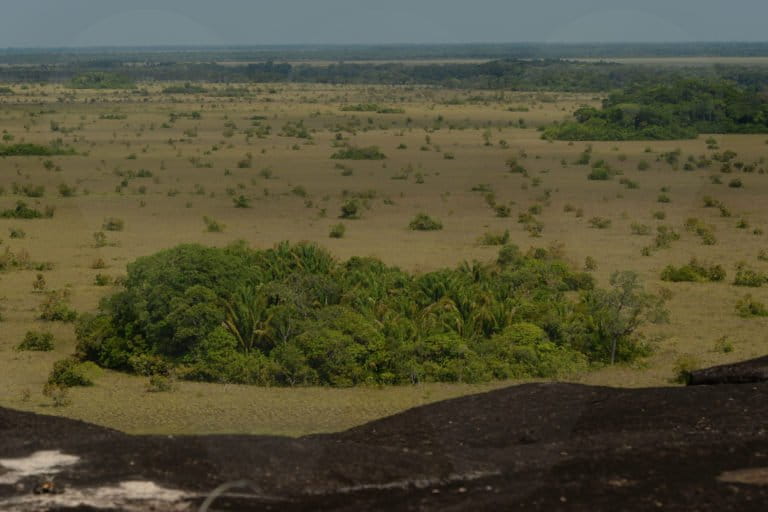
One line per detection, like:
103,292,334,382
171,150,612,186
0,41,768,65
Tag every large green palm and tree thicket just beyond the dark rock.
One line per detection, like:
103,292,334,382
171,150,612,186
77,243,665,386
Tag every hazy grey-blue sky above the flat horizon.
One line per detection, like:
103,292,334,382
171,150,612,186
0,0,768,47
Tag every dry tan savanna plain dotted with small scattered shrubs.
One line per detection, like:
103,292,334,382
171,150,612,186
0,84,768,435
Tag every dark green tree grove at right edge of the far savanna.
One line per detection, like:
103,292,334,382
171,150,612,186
544,79,768,140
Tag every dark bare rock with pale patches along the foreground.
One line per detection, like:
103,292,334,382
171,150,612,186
0,357,768,512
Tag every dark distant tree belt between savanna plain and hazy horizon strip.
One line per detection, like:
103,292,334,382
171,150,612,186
0,59,768,92
